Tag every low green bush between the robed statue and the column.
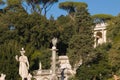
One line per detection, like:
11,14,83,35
31,48,52,70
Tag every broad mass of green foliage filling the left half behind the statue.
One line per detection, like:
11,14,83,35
0,0,58,80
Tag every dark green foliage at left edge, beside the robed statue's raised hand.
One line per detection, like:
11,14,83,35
0,40,20,80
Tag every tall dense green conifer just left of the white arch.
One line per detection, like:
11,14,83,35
68,2,94,67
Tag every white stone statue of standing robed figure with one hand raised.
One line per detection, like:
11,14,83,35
15,48,29,80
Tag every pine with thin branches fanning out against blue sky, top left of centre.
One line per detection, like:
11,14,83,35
26,0,58,16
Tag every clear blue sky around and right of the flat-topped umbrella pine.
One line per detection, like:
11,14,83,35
47,0,120,19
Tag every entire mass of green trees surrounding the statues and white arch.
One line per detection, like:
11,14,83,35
0,0,120,80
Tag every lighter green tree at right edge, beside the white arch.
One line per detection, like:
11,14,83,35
107,15,120,73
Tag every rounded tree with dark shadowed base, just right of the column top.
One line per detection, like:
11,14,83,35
56,16,75,55
